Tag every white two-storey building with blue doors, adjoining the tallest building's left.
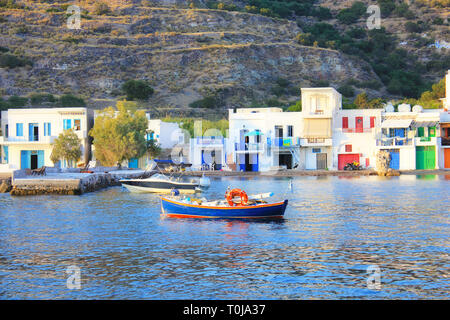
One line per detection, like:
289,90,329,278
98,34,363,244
226,108,302,171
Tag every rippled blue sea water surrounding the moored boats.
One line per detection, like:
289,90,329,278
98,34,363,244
0,176,450,299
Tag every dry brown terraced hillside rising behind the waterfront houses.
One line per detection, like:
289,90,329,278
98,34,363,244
0,0,449,116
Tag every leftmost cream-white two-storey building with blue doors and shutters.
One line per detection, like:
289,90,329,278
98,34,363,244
0,108,93,171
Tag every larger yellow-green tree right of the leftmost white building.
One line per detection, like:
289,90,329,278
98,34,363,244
89,104,148,166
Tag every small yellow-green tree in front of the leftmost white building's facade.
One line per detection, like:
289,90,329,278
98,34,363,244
50,129,81,168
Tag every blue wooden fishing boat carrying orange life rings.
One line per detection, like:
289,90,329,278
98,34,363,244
161,189,288,219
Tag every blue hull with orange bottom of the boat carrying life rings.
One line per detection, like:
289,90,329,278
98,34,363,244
161,197,288,219
